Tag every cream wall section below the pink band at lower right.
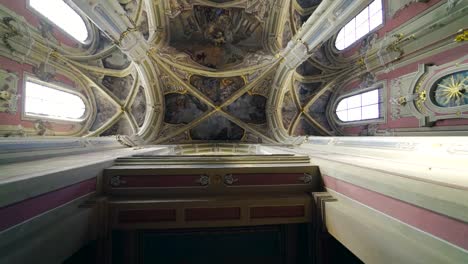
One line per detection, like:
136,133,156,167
325,190,468,264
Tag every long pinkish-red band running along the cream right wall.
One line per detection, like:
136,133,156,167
323,175,468,250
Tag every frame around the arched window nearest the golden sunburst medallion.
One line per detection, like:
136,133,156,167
330,82,387,126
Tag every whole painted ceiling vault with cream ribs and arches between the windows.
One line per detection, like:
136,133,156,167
65,0,370,144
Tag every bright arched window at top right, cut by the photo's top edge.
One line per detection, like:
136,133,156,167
335,0,383,50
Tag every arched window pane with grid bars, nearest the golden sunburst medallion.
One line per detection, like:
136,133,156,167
335,89,382,122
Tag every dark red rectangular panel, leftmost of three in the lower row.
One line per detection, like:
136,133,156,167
118,209,176,224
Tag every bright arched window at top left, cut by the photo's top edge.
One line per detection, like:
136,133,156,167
29,0,88,43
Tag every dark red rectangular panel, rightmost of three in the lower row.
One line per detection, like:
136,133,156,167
250,205,305,219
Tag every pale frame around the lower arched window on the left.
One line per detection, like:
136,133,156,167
21,73,91,124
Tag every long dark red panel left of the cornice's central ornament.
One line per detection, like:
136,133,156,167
109,175,205,188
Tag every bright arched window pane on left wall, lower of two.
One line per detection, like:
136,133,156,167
24,78,86,122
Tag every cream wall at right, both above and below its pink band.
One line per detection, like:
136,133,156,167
290,137,468,263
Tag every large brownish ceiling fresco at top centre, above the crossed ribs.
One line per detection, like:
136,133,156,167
168,5,273,70
